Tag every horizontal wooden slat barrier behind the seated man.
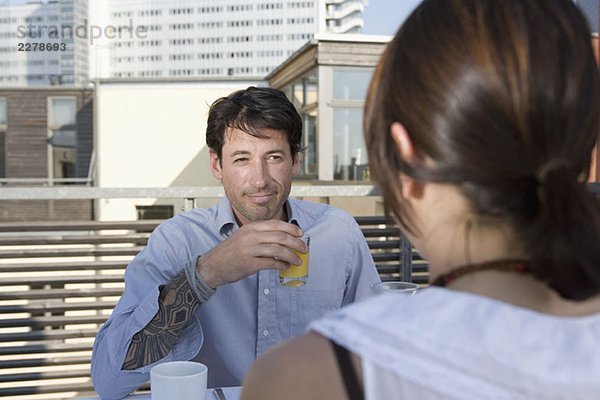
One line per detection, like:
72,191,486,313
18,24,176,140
0,217,427,399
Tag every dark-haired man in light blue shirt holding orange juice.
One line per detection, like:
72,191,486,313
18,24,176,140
92,87,379,399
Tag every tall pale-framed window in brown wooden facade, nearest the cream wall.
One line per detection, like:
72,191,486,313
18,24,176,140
48,97,77,179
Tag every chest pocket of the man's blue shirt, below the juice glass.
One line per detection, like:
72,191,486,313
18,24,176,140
290,288,344,335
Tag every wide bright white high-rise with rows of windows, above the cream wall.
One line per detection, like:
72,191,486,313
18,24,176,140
90,0,367,78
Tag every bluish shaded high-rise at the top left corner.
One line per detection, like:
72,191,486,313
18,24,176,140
0,0,89,87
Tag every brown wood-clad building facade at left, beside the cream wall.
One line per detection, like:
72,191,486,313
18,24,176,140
0,86,93,221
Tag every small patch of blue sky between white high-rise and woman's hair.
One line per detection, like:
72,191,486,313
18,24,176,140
363,0,421,35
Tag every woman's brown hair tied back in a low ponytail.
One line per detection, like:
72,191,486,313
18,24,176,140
365,0,600,300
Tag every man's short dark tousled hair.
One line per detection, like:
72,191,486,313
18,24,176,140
206,86,302,159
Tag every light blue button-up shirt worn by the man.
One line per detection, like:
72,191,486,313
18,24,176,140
92,198,380,399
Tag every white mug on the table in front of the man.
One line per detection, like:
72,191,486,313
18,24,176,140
150,361,208,400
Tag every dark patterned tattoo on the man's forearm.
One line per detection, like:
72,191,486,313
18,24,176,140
121,271,200,370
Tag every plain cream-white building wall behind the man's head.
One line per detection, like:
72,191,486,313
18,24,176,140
94,77,267,220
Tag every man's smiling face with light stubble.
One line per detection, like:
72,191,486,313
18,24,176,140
210,129,299,225
